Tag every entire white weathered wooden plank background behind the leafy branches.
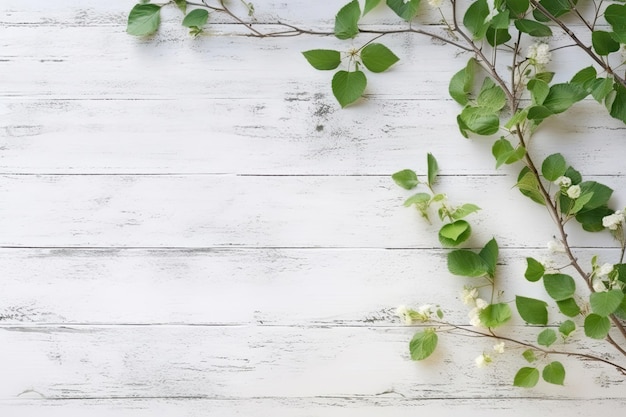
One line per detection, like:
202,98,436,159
0,0,626,417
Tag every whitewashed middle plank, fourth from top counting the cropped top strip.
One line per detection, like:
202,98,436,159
0,175,625,248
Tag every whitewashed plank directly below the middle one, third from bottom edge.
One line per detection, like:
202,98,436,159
0,249,617,326
